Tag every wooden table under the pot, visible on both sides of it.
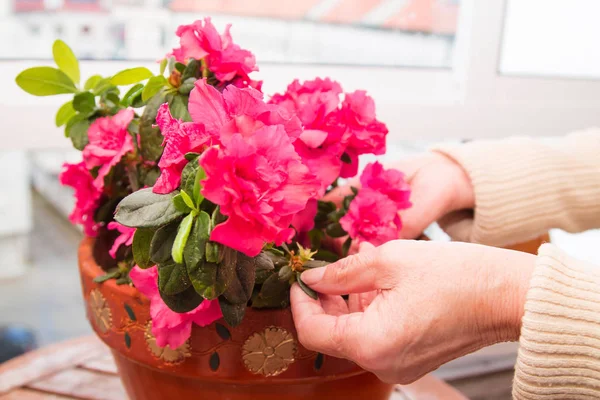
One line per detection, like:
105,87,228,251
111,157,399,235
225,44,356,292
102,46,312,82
0,336,466,400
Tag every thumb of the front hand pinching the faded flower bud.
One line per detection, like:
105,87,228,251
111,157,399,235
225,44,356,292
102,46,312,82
302,249,395,295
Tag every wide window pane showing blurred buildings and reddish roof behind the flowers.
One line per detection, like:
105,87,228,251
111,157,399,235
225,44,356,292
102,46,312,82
0,0,460,68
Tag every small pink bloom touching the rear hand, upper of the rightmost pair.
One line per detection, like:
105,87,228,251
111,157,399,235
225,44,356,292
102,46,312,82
360,162,411,210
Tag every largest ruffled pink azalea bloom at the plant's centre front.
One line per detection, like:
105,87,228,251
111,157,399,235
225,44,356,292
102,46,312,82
200,125,320,257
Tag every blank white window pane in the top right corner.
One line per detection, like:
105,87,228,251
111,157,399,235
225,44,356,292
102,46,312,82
500,0,600,78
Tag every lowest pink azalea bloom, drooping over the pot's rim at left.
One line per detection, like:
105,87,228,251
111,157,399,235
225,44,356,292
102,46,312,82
129,265,222,349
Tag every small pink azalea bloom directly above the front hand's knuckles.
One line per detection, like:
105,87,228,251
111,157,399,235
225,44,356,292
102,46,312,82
340,188,402,246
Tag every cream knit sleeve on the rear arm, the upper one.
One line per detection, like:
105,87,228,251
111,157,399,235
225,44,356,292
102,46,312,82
434,129,600,246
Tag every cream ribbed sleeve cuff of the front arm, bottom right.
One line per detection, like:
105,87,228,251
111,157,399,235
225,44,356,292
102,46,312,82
513,244,600,400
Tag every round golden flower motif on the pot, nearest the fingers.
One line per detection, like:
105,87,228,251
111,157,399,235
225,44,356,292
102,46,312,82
242,326,297,376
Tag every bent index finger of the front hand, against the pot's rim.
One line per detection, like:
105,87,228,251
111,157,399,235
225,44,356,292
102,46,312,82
291,285,362,358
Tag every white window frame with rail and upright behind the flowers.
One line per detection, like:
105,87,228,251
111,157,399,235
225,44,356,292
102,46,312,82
0,0,600,148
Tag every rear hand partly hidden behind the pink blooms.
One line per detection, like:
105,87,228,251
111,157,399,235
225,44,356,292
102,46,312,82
324,152,475,239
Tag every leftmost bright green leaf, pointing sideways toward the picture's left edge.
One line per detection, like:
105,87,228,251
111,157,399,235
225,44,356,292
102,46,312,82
16,67,77,96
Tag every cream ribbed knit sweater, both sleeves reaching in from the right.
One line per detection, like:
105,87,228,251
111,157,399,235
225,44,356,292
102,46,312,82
435,129,600,400
